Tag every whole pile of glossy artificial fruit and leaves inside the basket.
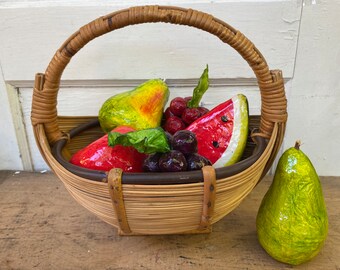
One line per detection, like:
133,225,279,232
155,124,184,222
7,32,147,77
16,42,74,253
70,66,248,172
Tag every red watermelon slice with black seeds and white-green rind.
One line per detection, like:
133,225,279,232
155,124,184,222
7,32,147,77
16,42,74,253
186,94,248,168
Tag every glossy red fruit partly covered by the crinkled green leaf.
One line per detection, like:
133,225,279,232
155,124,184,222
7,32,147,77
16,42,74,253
70,126,146,172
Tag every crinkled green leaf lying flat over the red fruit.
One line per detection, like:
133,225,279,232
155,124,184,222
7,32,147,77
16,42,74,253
108,128,170,154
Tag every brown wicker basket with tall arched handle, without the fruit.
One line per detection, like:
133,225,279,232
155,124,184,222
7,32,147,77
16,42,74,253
31,6,287,235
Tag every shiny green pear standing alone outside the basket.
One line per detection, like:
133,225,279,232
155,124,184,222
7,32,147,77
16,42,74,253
256,142,328,265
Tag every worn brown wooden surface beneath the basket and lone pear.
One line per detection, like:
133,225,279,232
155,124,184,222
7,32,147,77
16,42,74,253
0,171,340,270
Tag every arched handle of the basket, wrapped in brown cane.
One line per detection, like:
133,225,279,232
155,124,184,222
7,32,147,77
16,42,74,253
31,6,287,144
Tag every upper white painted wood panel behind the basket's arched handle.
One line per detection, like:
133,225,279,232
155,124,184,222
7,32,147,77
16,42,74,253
0,1,301,81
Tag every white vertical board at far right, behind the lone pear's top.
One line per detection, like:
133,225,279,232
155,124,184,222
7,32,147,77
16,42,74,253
284,0,340,176
